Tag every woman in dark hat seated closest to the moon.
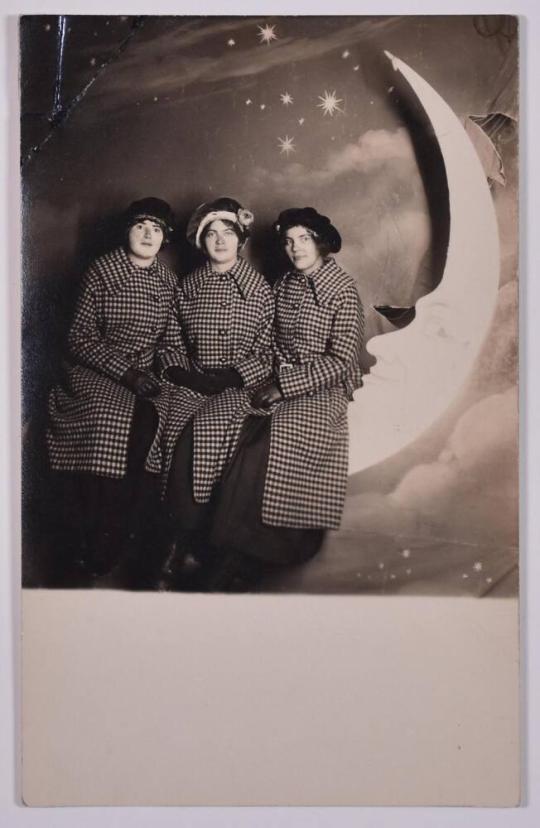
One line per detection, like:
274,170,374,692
200,207,364,590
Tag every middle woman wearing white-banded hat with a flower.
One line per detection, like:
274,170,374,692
154,197,274,581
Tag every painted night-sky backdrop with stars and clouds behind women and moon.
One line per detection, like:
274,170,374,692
21,16,518,595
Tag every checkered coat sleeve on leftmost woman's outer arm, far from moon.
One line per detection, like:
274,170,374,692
68,268,132,381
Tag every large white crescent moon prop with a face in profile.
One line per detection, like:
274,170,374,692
349,52,499,474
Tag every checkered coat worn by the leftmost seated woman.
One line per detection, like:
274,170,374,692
47,248,184,477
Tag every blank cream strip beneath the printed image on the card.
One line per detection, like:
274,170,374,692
22,590,519,807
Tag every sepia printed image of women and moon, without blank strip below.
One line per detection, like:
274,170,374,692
20,15,518,597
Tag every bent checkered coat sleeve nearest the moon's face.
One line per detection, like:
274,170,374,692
279,288,364,399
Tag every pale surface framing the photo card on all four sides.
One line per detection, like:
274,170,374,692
0,0,540,828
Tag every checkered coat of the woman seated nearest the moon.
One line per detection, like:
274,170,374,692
262,257,364,529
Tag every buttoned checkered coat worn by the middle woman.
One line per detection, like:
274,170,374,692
146,258,274,502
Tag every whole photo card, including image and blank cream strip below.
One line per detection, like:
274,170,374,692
16,9,521,804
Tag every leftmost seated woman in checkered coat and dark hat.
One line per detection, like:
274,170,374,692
47,198,183,574
